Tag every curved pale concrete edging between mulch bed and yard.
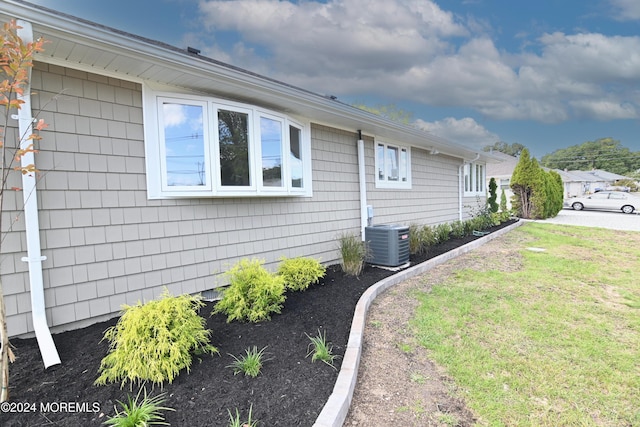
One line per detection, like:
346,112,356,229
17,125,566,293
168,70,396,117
313,221,524,427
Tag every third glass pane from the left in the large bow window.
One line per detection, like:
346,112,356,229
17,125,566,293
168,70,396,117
260,117,283,187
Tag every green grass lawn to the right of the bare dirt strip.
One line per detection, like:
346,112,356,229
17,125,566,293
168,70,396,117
412,223,640,427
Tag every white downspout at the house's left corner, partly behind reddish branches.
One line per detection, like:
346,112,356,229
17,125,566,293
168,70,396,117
18,20,60,369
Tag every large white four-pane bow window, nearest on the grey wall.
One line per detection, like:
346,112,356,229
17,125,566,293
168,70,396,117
145,95,311,198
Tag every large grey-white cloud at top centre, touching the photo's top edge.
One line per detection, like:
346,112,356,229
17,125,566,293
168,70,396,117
200,0,466,77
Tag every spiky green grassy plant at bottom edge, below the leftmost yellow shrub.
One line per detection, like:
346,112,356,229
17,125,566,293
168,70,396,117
104,389,174,427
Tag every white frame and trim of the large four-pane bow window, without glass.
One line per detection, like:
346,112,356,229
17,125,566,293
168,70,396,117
143,86,312,199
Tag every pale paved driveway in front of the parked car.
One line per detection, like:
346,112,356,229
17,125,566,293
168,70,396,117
539,208,640,231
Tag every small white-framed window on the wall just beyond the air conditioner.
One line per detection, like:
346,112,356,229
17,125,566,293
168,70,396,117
375,142,411,188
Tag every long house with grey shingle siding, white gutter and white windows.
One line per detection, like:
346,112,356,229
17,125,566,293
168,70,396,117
0,0,493,344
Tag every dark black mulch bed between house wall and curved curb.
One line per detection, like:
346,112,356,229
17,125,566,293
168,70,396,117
0,222,512,427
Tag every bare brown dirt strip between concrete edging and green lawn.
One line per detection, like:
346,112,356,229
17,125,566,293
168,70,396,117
344,233,526,427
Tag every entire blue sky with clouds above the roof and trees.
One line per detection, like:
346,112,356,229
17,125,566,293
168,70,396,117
31,0,640,157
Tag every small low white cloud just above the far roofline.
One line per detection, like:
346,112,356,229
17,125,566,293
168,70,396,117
414,117,500,149
